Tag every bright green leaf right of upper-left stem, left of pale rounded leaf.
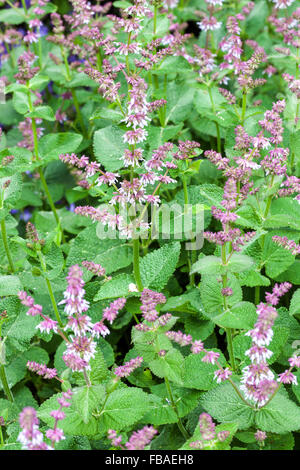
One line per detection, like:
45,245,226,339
39,132,82,159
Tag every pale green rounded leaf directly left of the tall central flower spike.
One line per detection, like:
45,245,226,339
93,126,127,171
